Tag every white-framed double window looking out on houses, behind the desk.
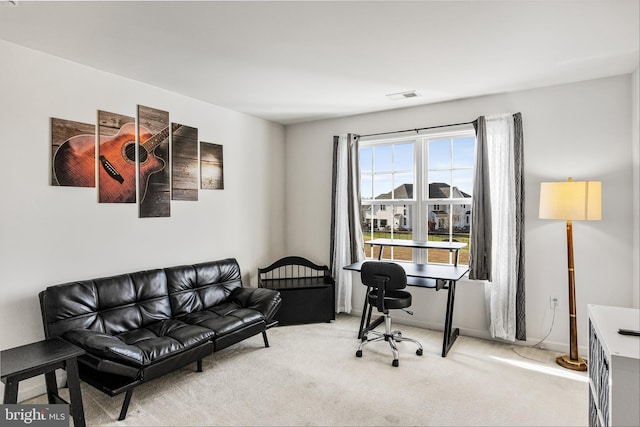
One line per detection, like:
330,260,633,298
360,129,476,264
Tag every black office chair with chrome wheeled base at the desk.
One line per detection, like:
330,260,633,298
356,261,422,367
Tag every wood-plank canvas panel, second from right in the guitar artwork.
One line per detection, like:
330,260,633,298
171,124,198,201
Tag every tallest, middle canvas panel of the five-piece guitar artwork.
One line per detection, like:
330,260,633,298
138,105,171,218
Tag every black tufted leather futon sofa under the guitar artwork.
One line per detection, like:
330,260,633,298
39,259,281,420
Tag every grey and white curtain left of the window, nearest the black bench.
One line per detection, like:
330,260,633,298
330,134,365,313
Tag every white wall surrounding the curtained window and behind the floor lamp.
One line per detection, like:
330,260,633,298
285,75,634,352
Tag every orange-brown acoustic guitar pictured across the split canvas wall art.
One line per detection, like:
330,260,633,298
53,123,181,203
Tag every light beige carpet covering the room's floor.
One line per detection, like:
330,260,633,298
29,315,588,426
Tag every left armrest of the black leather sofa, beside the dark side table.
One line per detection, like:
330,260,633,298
62,329,148,367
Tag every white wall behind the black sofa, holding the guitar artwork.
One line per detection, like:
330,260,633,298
0,41,284,402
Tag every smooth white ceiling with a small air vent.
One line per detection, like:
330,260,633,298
0,0,640,125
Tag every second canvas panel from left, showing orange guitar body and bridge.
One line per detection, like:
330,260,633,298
98,111,136,203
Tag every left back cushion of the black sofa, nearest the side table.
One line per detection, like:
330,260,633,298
40,269,171,338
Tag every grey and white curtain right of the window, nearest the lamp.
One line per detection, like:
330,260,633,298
469,113,526,341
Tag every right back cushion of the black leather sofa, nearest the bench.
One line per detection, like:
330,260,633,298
165,258,242,318
